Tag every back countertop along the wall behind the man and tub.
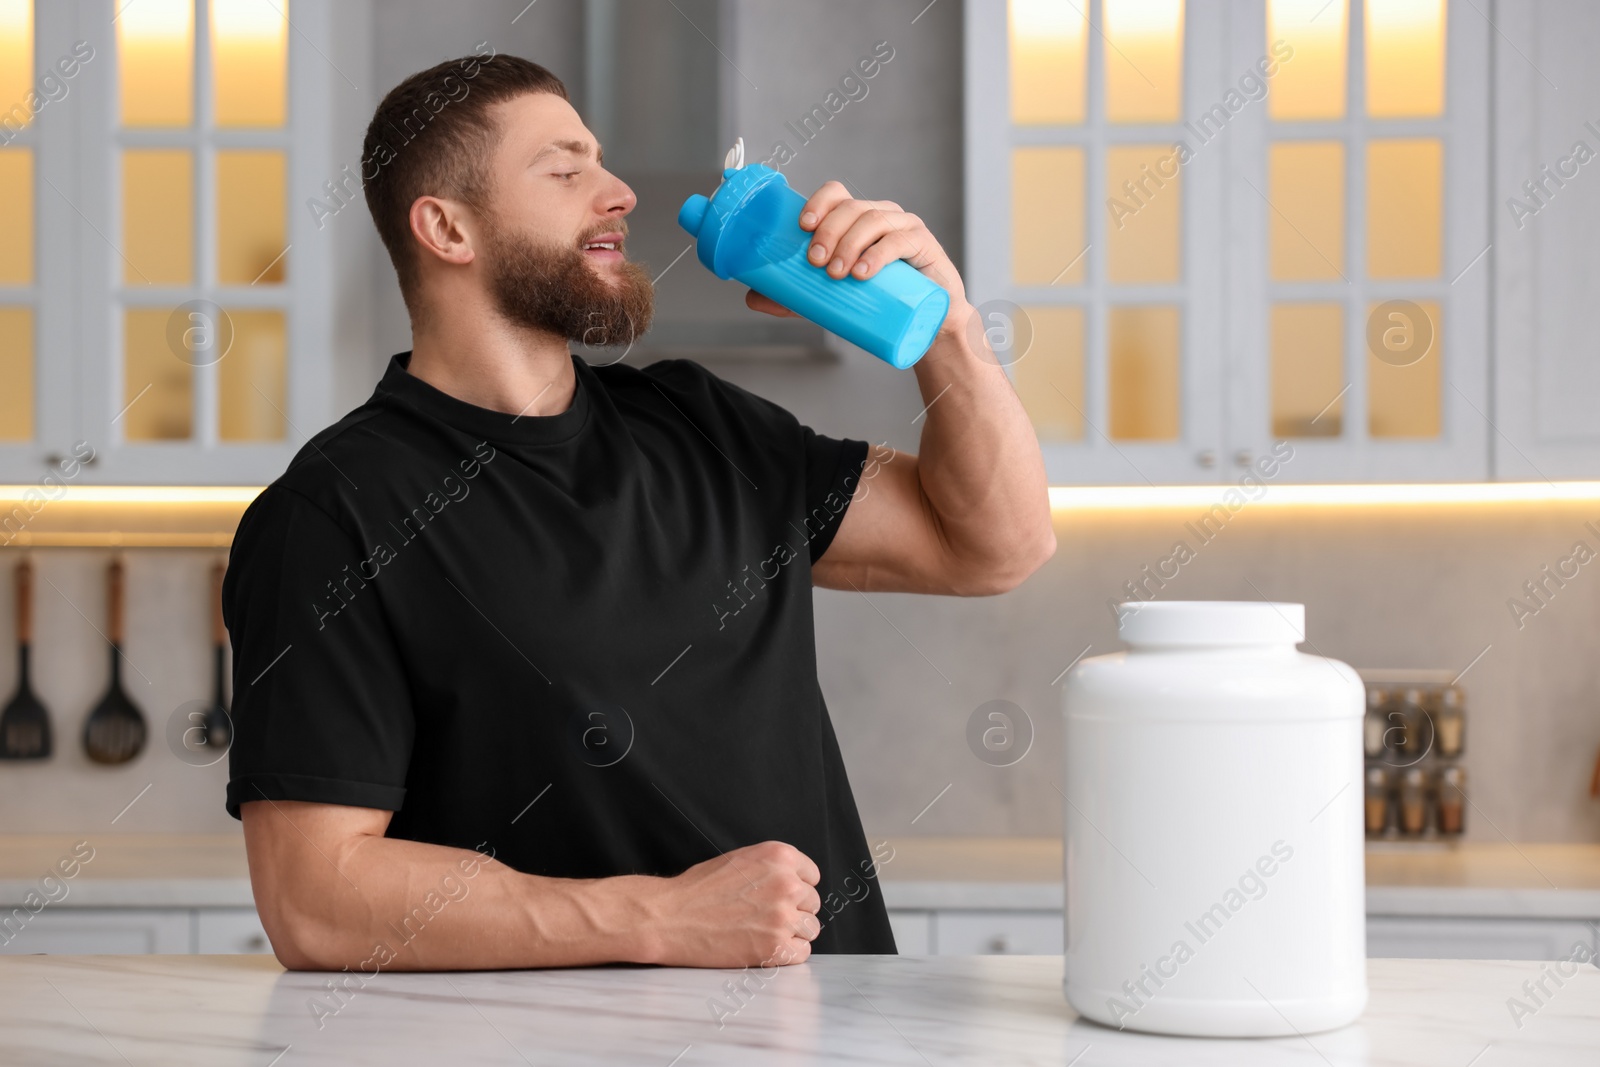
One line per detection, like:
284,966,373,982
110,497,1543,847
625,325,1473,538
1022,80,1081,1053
0,833,1600,920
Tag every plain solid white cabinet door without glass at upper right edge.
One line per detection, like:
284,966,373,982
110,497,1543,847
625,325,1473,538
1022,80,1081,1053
1491,0,1600,482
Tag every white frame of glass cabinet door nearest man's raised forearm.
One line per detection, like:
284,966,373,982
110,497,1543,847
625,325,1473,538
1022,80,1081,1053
965,0,1226,485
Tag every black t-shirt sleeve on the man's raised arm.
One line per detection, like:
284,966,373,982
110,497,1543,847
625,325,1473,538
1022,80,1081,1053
650,360,867,563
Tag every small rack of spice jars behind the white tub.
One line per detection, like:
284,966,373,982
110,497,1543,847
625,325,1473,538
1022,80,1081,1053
1360,670,1467,841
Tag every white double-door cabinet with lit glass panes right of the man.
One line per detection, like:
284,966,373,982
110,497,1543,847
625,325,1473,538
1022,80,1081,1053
965,0,1497,485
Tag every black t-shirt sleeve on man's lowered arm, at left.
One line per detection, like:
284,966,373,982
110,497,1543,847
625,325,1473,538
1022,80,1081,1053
222,485,414,819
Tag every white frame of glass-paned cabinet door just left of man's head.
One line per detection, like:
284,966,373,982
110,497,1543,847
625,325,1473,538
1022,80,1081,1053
72,0,334,485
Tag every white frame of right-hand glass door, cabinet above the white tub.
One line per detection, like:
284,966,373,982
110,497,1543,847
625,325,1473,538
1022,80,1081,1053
1227,0,1494,483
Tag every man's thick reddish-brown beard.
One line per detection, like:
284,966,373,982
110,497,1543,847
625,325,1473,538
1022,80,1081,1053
485,221,656,346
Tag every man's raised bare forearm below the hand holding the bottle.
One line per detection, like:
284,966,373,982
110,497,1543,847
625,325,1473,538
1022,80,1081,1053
915,309,1054,584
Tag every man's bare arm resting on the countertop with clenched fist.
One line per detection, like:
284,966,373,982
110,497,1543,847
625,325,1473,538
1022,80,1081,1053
243,800,821,974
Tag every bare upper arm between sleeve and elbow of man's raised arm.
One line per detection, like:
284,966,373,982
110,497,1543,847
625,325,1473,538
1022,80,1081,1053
811,450,962,593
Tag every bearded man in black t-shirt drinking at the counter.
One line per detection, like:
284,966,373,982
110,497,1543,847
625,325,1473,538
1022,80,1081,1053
224,54,1056,974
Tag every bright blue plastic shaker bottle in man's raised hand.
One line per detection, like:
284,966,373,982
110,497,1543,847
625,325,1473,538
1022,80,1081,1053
678,163,950,370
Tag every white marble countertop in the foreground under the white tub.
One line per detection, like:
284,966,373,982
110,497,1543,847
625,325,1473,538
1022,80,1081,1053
0,955,1600,1067
